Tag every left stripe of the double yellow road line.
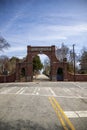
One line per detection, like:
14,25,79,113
49,97,68,130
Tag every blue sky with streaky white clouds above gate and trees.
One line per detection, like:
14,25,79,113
0,0,87,57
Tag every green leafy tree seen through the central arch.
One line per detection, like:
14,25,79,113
33,56,43,72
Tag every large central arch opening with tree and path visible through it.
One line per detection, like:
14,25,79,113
33,54,50,81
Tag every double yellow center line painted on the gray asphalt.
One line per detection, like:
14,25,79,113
49,97,75,130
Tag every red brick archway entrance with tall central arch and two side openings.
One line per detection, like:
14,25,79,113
16,45,67,82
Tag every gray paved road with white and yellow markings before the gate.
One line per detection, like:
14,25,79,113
0,81,87,130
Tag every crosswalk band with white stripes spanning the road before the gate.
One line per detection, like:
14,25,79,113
0,85,87,99
